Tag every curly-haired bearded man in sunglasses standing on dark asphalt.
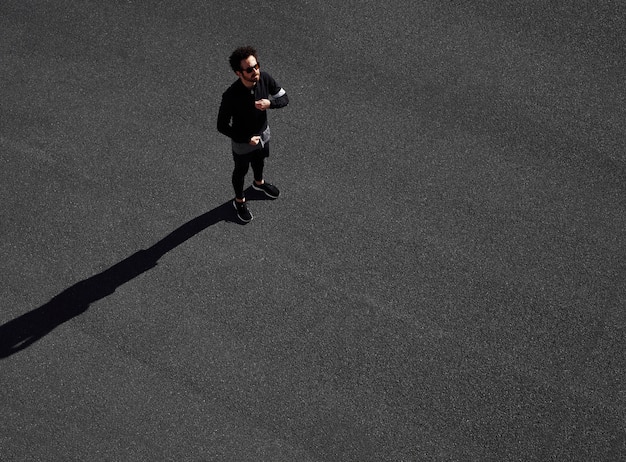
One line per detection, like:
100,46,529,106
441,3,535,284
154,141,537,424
217,47,289,223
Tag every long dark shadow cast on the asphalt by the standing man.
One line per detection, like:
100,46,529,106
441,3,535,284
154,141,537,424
0,191,261,358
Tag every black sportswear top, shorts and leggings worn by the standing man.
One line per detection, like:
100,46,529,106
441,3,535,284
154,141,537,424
217,72,289,199
